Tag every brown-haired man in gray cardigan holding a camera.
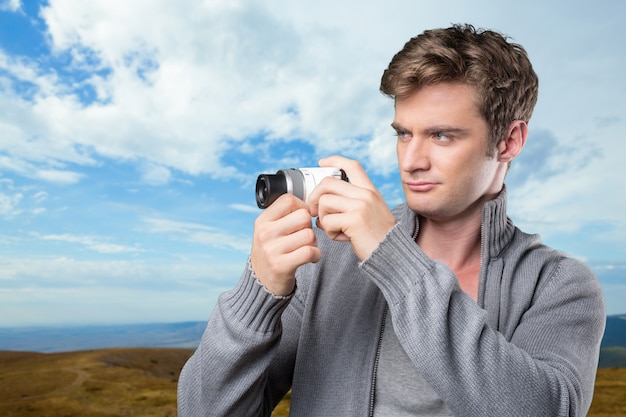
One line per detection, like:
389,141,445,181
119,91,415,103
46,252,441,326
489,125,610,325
179,26,605,417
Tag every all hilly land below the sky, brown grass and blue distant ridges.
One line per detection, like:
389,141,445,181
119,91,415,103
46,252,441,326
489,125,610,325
0,315,626,417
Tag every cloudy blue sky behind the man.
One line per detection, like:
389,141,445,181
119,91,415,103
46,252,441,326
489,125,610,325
0,0,626,327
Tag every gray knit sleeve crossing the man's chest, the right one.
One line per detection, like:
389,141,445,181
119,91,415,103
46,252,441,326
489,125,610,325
361,226,605,416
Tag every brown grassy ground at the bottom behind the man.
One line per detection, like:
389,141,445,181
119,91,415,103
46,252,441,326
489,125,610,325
0,348,626,417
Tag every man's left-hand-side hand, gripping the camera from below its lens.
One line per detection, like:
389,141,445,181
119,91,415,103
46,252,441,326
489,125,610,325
250,194,322,296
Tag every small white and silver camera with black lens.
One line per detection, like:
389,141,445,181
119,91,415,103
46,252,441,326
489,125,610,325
256,168,348,209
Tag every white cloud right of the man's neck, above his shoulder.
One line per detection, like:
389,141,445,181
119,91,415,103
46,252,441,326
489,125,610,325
511,120,626,252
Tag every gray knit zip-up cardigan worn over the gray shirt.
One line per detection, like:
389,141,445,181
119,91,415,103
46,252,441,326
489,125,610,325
178,191,605,417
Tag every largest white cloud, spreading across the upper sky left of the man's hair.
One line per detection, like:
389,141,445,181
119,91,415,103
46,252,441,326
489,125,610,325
4,0,394,176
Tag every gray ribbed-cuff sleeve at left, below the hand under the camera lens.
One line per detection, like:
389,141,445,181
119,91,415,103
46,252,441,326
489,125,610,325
178,265,298,417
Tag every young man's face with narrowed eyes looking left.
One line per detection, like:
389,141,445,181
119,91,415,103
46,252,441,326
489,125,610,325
392,83,506,220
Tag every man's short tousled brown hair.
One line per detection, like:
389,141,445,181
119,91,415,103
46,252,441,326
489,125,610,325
380,25,539,152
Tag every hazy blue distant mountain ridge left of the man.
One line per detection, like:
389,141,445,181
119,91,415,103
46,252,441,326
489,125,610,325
0,322,206,353
